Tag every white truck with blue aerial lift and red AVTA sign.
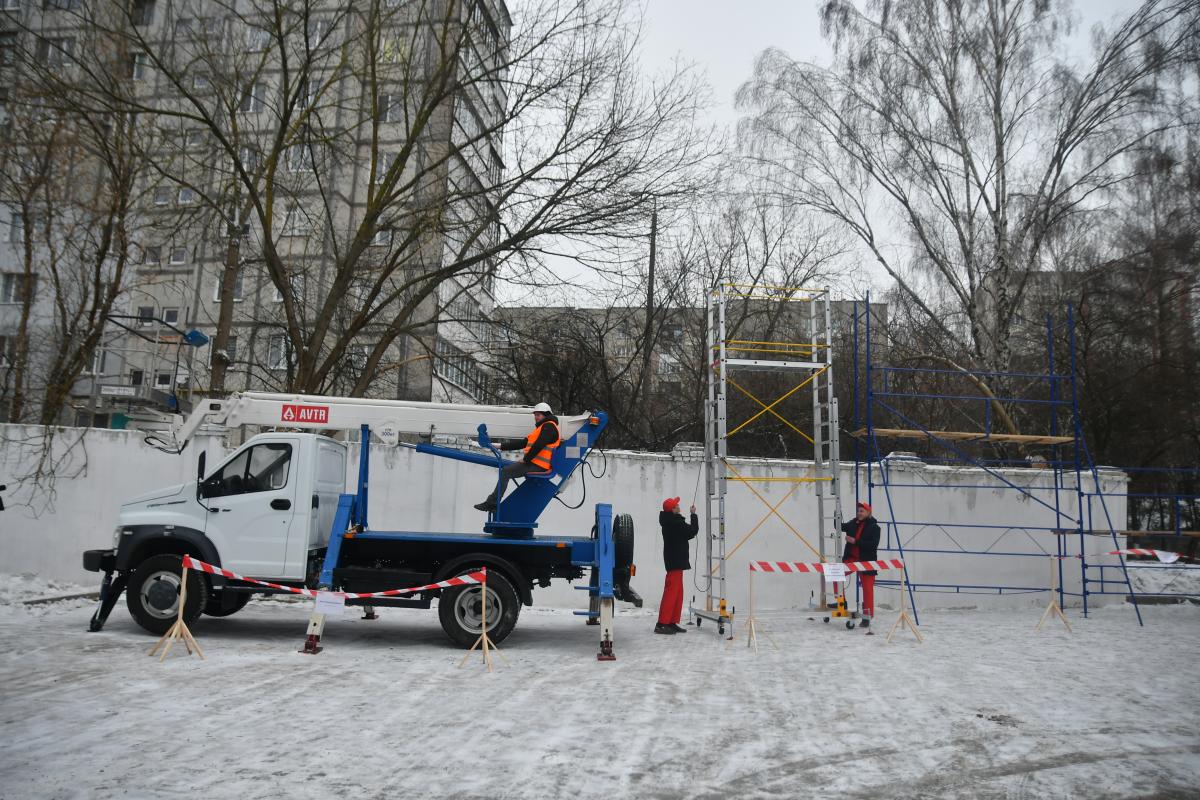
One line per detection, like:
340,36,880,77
83,392,641,660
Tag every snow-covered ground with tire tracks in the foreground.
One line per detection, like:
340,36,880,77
0,577,1200,800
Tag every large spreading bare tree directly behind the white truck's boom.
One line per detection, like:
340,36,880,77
25,0,714,393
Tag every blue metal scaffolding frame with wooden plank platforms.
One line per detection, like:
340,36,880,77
852,294,1200,625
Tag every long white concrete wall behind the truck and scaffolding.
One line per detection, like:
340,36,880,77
0,426,1126,609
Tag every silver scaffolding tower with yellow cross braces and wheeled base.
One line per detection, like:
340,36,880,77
688,284,842,636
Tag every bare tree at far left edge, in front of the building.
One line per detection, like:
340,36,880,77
0,25,157,425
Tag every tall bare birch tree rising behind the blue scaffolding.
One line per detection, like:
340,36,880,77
739,0,1196,379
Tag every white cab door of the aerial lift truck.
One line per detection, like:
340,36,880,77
200,440,297,578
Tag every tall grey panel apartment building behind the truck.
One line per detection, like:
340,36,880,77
0,0,511,425
